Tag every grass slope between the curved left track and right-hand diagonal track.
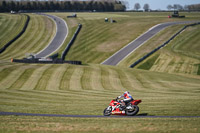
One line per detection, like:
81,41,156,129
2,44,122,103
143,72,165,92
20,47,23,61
49,13,198,63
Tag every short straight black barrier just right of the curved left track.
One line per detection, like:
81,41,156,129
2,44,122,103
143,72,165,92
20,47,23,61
61,24,82,61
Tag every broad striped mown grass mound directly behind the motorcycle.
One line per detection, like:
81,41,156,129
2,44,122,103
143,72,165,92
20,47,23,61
0,63,200,116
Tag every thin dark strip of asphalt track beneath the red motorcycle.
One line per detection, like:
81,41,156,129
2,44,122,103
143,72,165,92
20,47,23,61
0,112,200,118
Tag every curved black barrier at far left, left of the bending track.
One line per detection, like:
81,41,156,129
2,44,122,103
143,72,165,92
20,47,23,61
0,14,30,54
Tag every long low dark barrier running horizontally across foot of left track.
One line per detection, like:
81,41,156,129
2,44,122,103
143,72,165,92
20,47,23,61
11,58,82,65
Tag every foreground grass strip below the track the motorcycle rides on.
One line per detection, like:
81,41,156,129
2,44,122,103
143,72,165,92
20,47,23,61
0,116,200,133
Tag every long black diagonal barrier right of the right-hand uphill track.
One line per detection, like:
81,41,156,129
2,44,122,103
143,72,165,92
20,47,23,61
129,22,200,68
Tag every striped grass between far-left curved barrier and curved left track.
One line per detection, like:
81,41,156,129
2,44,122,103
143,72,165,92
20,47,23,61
0,14,56,60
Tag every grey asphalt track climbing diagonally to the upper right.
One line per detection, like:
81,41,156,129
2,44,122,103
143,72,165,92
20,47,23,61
101,21,199,66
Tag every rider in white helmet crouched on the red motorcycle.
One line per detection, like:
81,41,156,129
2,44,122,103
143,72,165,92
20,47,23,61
117,91,133,110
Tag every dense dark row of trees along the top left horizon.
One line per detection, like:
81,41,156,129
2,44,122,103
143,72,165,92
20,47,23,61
0,0,126,12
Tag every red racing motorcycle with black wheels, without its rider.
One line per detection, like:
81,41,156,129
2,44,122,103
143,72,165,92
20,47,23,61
103,98,142,116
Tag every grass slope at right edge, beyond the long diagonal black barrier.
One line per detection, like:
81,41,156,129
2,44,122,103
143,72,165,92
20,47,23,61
131,23,200,75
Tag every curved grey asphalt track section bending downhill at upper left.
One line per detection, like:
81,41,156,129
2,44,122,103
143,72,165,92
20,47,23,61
35,14,68,58
